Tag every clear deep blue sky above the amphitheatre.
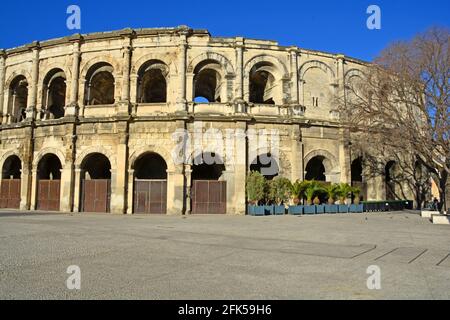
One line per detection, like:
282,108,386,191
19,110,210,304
0,0,450,60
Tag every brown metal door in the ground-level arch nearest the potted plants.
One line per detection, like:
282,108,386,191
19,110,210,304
192,180,227,214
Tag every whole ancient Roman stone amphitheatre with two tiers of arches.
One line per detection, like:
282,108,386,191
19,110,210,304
0,26,386,214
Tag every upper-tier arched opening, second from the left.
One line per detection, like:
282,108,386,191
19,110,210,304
42,69,66,120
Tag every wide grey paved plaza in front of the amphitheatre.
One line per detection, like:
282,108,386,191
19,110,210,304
0,212,450,299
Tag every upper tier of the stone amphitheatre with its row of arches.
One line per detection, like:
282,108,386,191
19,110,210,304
0,26,366,127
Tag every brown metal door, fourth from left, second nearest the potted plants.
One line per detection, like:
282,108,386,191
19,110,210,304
134,179,167,214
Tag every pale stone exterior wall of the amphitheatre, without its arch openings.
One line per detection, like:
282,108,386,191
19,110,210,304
0,26,384,214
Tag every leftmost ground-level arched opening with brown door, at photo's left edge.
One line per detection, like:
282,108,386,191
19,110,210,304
0,155,22,209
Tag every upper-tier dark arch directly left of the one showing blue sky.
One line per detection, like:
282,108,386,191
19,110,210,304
137,60,169,103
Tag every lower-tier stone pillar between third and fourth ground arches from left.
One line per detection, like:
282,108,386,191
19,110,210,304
111,129,128,214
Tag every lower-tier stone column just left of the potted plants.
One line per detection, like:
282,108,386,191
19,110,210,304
233,121,248,215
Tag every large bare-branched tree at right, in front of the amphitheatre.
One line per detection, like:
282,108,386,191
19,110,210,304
338,28,450,210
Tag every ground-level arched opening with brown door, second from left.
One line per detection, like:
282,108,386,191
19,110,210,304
36,154,62,211
